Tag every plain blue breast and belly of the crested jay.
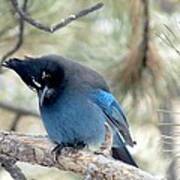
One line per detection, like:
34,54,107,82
41,90,105,145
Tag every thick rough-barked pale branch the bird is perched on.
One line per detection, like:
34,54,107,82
0,132,166,180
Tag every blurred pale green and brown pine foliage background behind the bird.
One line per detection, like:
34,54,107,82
0,0,180,180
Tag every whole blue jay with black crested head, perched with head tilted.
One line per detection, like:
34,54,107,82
3,54,138,167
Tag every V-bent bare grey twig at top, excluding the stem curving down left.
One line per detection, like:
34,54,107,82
10,0,103,33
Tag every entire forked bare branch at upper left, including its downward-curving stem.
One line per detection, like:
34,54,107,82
0,0,103,69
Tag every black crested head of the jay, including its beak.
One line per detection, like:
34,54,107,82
3,57,65,106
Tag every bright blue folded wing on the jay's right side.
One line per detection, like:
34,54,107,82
91,89,134,146
